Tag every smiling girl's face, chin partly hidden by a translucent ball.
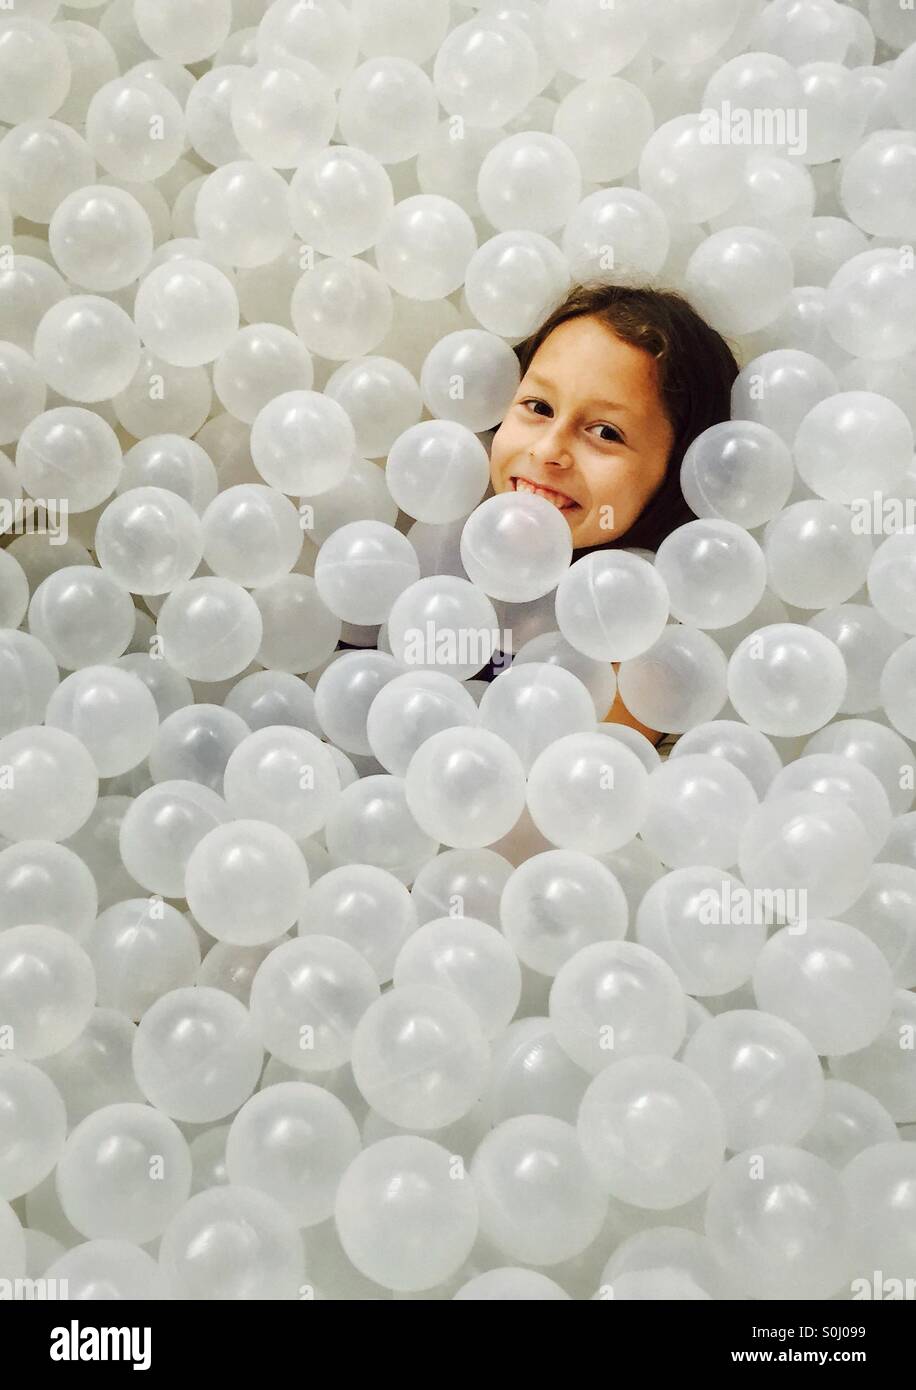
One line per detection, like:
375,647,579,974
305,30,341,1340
489,316,674,549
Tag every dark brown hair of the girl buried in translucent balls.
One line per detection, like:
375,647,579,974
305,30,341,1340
505,281,738,559
